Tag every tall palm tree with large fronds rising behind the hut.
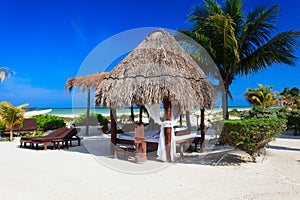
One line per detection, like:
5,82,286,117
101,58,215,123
180,0,300,119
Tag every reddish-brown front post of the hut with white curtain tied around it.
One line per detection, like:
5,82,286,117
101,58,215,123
163,99,172,162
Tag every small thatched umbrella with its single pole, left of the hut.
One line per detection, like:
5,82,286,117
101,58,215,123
65,72,109,136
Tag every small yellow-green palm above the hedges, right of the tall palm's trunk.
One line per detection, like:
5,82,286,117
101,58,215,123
243,84,278,108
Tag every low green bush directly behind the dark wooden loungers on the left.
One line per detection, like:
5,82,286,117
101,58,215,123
32,115,66,131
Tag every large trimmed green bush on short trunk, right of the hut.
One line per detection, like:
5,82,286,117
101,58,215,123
220,118,286,162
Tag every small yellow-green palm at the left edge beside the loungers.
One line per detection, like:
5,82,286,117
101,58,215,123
0,101,28,141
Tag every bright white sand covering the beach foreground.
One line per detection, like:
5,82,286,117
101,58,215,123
0,133,300,200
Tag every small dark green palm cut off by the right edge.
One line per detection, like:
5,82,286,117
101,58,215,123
279,87,300,108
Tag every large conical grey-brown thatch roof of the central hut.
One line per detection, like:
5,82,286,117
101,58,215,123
95,30,216,110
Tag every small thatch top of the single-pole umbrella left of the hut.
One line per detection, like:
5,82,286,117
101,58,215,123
65,72,109,91
